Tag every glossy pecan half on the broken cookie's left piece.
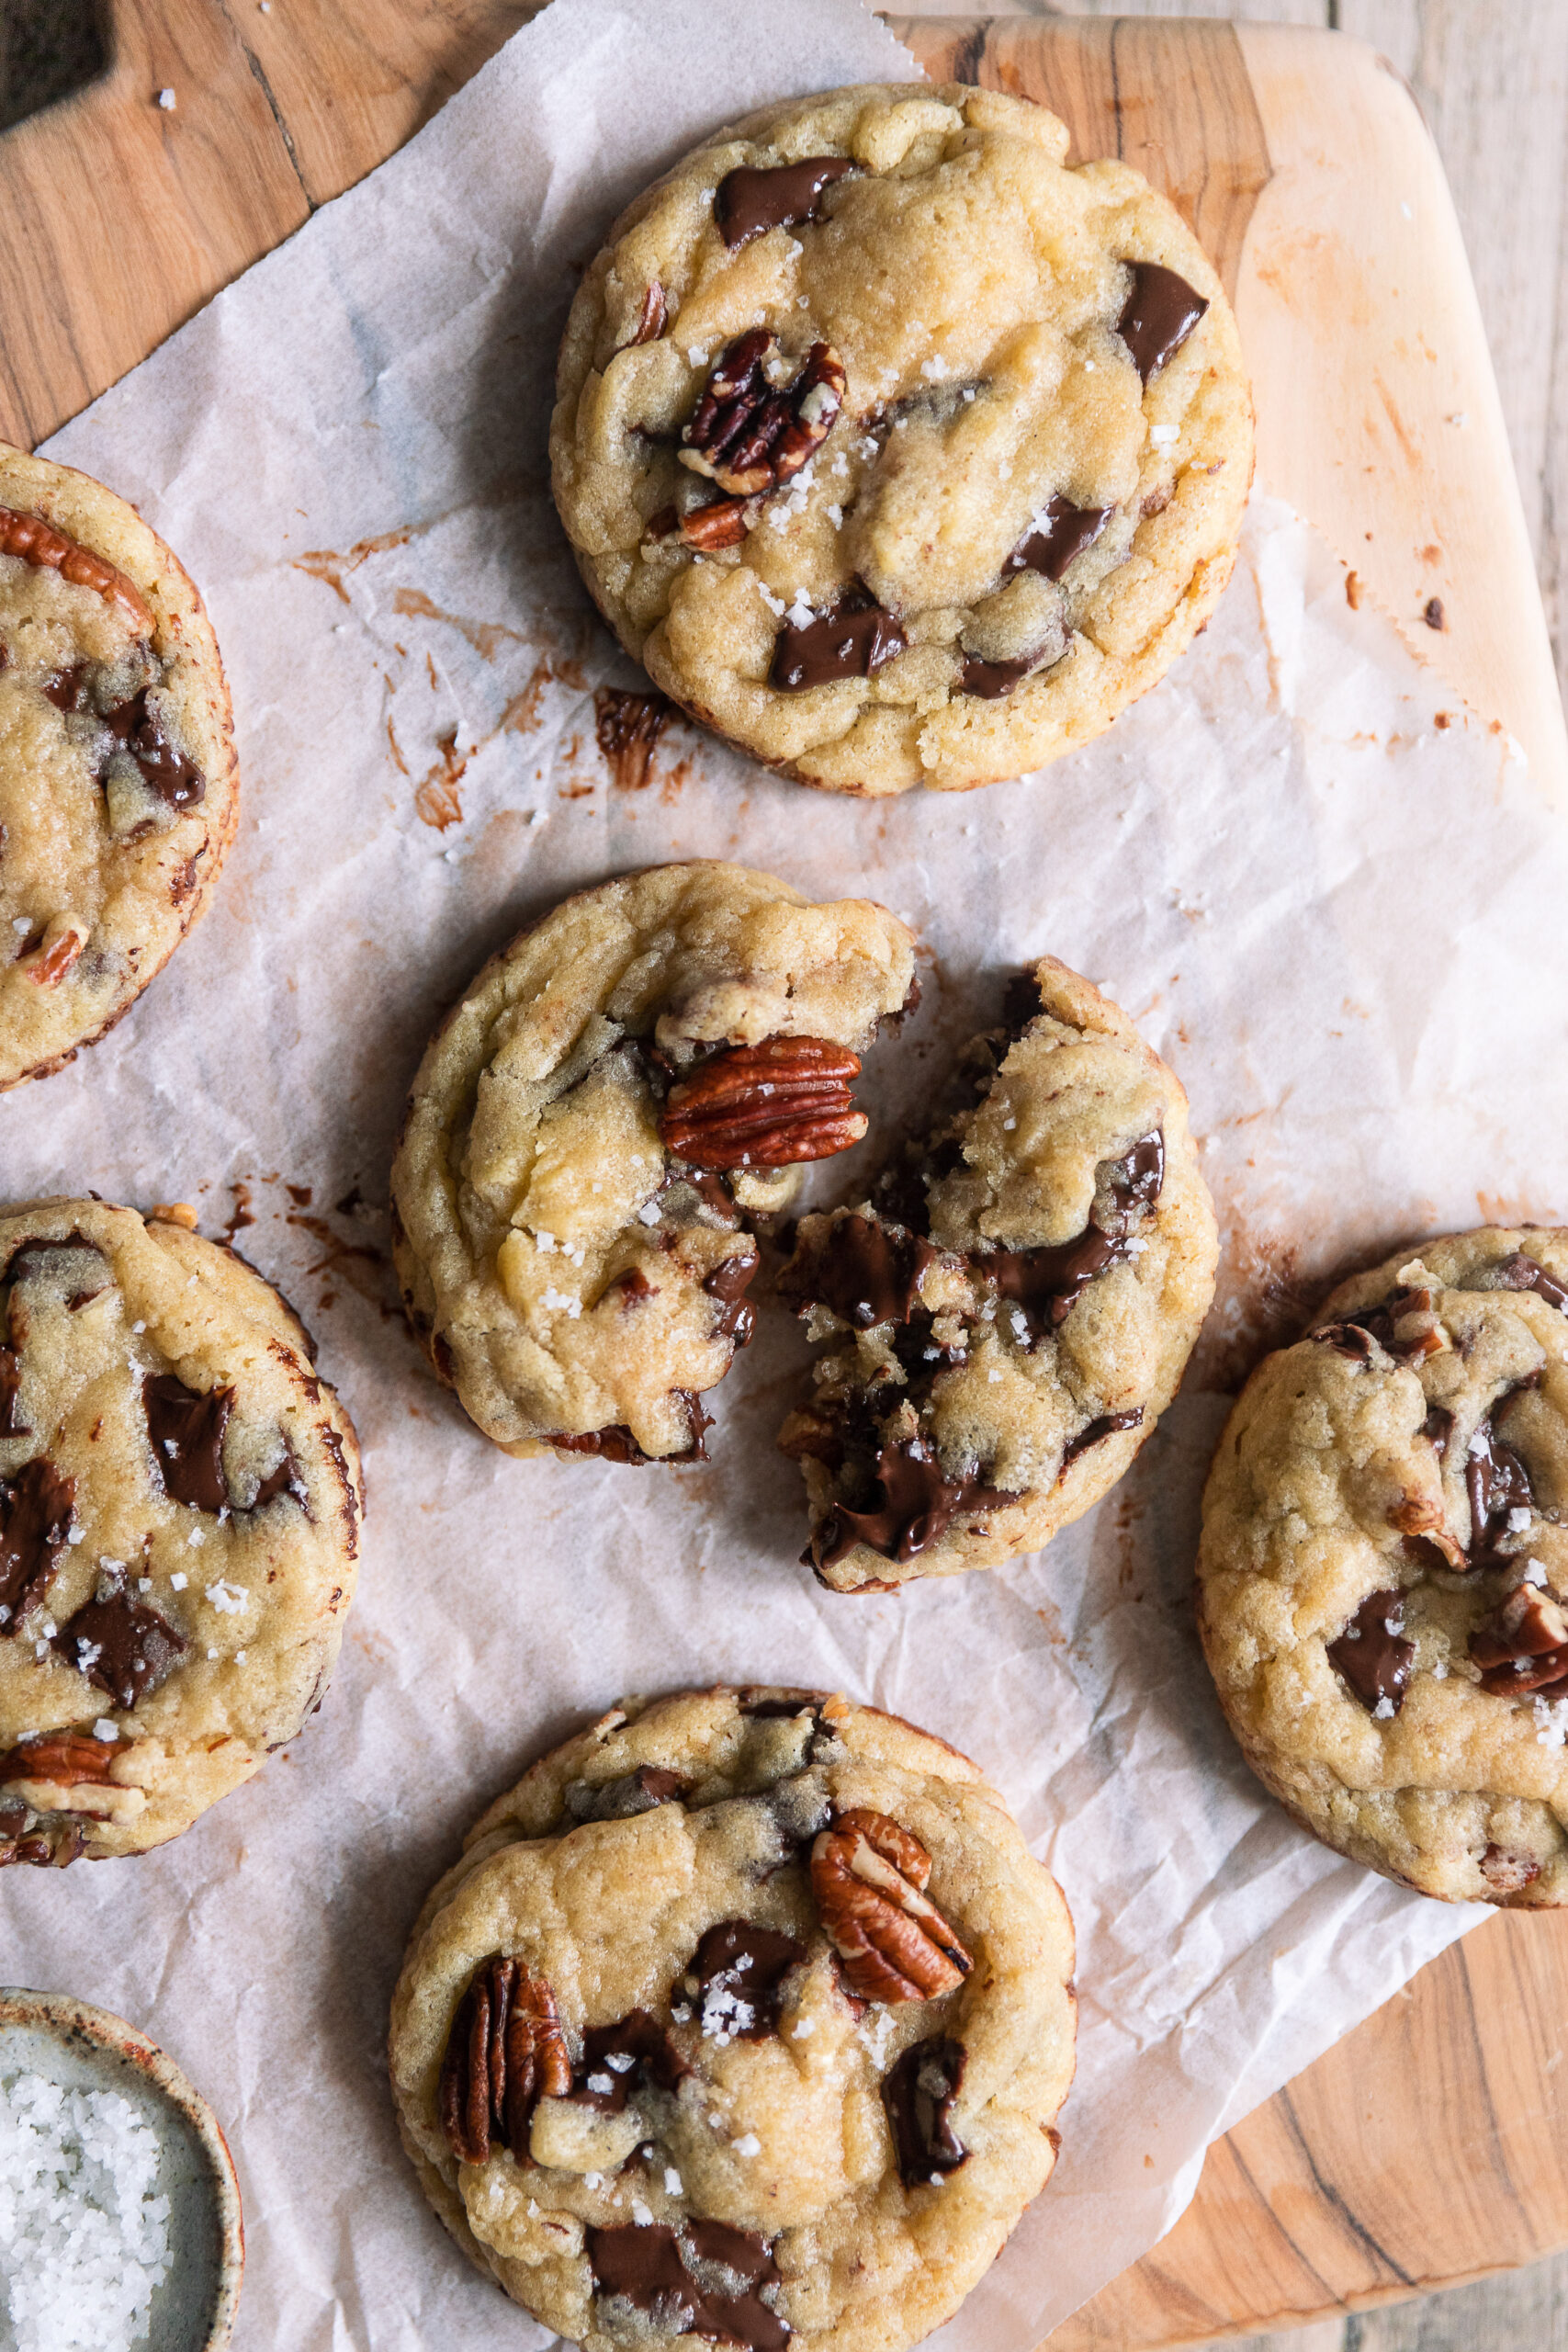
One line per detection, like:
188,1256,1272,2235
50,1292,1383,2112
659,1037,865,1169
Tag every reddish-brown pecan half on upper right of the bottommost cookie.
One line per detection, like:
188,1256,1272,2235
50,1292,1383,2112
811,1806,974,2002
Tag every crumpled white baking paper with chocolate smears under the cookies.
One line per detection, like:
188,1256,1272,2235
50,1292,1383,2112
0,0,1568,2352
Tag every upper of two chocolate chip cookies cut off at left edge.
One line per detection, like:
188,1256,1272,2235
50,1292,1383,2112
0,442,240,1091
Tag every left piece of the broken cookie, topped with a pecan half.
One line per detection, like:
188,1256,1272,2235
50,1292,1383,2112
392,864,915,1463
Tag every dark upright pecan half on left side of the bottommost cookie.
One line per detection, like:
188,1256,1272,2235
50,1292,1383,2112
437,1952,571,2164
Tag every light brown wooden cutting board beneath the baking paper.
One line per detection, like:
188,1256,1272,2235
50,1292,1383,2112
0,0,1568,2352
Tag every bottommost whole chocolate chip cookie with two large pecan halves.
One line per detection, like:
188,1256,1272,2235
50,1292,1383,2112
390,1689,1075,2352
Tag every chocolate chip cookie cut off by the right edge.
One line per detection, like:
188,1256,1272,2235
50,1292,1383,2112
1199,1226,1568,1905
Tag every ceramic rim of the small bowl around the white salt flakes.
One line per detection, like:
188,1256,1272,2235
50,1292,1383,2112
0,1985,244,2352
